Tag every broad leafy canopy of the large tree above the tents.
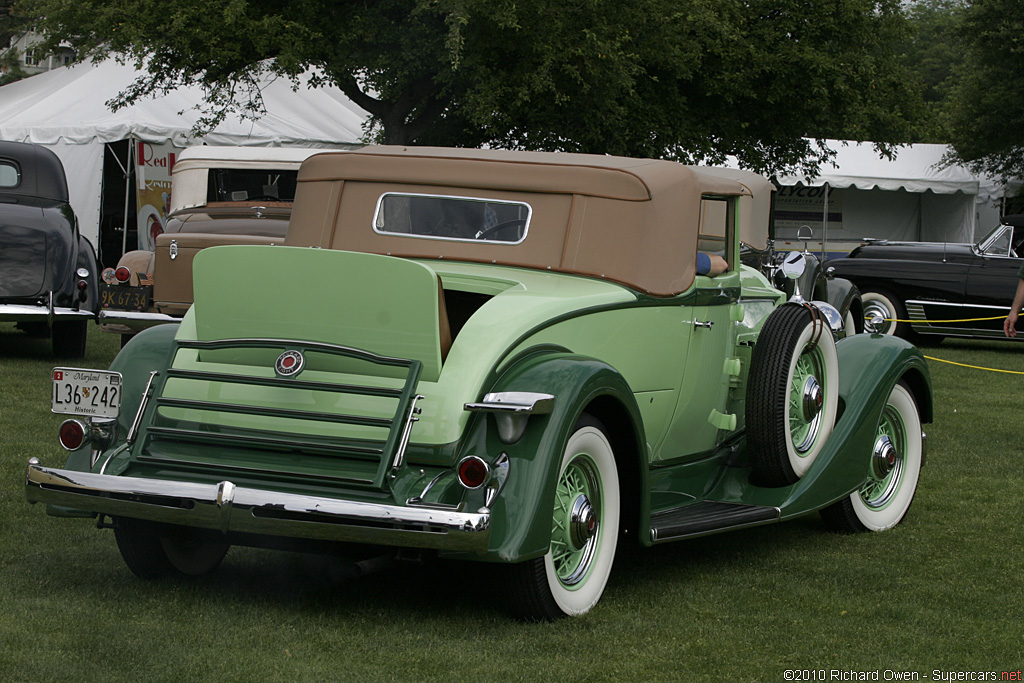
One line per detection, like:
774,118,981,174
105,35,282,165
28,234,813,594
20,0,922,173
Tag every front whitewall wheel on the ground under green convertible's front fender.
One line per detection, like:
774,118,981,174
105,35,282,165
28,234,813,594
821,384,924,531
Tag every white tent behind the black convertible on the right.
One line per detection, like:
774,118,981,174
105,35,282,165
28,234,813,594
775,140,1006,252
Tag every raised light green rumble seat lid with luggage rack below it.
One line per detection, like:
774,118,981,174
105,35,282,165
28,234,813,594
128,247,441,489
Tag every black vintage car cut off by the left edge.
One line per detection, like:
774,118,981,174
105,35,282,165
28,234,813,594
0,141,97,358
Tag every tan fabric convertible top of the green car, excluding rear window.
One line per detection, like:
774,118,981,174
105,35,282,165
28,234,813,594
286,146,770,296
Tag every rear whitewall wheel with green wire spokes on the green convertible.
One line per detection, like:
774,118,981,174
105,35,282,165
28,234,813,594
511,415,621,621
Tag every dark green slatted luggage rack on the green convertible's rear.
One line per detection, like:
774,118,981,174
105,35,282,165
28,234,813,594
135,338,423,489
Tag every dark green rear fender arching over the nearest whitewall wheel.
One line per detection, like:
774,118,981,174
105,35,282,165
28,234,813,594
468,353,645,561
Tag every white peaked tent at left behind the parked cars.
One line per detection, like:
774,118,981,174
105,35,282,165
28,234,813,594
0,58,368,250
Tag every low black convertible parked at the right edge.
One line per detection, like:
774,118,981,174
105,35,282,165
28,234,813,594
827,214,1024,341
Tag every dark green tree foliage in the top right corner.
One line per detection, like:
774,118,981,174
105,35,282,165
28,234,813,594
951,0,1024,178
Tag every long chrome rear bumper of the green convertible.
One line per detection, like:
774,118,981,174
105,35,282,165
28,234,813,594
26,458,490,553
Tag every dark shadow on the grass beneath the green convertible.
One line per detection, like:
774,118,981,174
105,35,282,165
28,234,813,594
39,515,849,620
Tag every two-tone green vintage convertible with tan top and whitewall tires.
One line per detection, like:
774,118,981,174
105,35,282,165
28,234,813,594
27,146,932,620
